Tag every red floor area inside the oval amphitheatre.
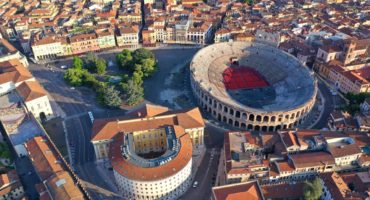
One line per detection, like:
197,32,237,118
222,67,269,90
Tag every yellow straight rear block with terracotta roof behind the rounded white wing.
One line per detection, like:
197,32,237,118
92,104,205,160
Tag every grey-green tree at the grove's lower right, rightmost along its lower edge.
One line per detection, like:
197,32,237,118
122,79,144,106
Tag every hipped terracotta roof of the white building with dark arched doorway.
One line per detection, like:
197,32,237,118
16,81,47,102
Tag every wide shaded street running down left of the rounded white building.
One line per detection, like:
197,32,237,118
29,61,121,199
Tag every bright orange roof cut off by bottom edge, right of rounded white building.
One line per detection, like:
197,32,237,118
212,181,264,200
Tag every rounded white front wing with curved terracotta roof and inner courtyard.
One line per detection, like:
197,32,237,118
110,126,192,199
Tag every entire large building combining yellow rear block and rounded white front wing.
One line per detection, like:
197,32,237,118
92,105,204,199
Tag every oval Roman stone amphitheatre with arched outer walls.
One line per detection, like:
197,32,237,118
190,42,317,131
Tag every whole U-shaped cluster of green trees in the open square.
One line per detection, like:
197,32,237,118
64,49,157,108
